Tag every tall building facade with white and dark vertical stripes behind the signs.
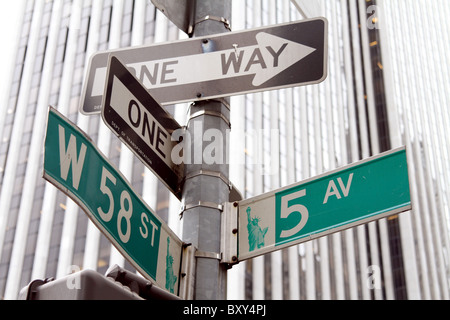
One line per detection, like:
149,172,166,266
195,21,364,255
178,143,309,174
0,0,450,299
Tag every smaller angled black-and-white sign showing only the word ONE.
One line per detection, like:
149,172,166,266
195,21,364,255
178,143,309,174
102,55,184,198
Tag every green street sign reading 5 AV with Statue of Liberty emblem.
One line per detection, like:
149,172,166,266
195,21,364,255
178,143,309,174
238,147,411,261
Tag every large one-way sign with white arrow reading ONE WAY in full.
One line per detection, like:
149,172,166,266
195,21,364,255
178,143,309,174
80,18,328,114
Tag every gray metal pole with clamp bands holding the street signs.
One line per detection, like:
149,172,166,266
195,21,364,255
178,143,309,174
182,0,231,300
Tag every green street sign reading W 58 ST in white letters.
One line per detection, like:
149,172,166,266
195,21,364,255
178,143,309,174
44,107,182,294
